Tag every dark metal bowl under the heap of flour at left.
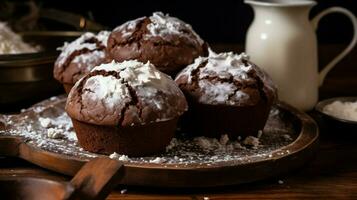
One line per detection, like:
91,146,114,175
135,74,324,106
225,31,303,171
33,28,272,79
0,31,83,112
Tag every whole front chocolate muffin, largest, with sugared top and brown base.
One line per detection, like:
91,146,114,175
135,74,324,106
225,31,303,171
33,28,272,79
66,60,187,156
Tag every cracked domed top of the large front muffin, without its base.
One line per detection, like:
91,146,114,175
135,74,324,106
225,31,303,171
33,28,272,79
66,60,187,126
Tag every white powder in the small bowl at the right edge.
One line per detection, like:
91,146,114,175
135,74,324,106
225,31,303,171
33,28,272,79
323,101,357,121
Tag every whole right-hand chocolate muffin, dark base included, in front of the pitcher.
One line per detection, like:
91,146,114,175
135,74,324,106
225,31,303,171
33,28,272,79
175,52,277,139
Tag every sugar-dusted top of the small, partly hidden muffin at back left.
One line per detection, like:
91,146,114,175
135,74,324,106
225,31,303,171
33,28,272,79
53,31,110,84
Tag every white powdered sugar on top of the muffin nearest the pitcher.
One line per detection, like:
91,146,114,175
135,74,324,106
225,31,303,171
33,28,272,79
176,51,253,105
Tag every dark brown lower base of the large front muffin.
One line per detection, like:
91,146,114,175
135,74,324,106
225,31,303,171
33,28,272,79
72,119,177,156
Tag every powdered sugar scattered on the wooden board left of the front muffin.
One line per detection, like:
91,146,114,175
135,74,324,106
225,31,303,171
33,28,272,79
0,96,94,158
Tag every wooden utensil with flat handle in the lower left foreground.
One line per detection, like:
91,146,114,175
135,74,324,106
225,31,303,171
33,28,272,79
0,157,123,200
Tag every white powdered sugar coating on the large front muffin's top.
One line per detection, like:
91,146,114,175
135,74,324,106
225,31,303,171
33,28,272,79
68,60,187,125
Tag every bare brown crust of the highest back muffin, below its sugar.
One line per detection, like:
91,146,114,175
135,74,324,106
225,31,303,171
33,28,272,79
107,17,208,76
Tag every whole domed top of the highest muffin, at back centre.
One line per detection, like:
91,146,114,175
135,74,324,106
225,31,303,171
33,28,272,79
107,12,208,75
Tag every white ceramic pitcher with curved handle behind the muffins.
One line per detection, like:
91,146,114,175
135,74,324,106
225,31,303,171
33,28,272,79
245,0,357,111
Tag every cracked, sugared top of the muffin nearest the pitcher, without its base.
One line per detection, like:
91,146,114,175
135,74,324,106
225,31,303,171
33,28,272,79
175,52,276,106
